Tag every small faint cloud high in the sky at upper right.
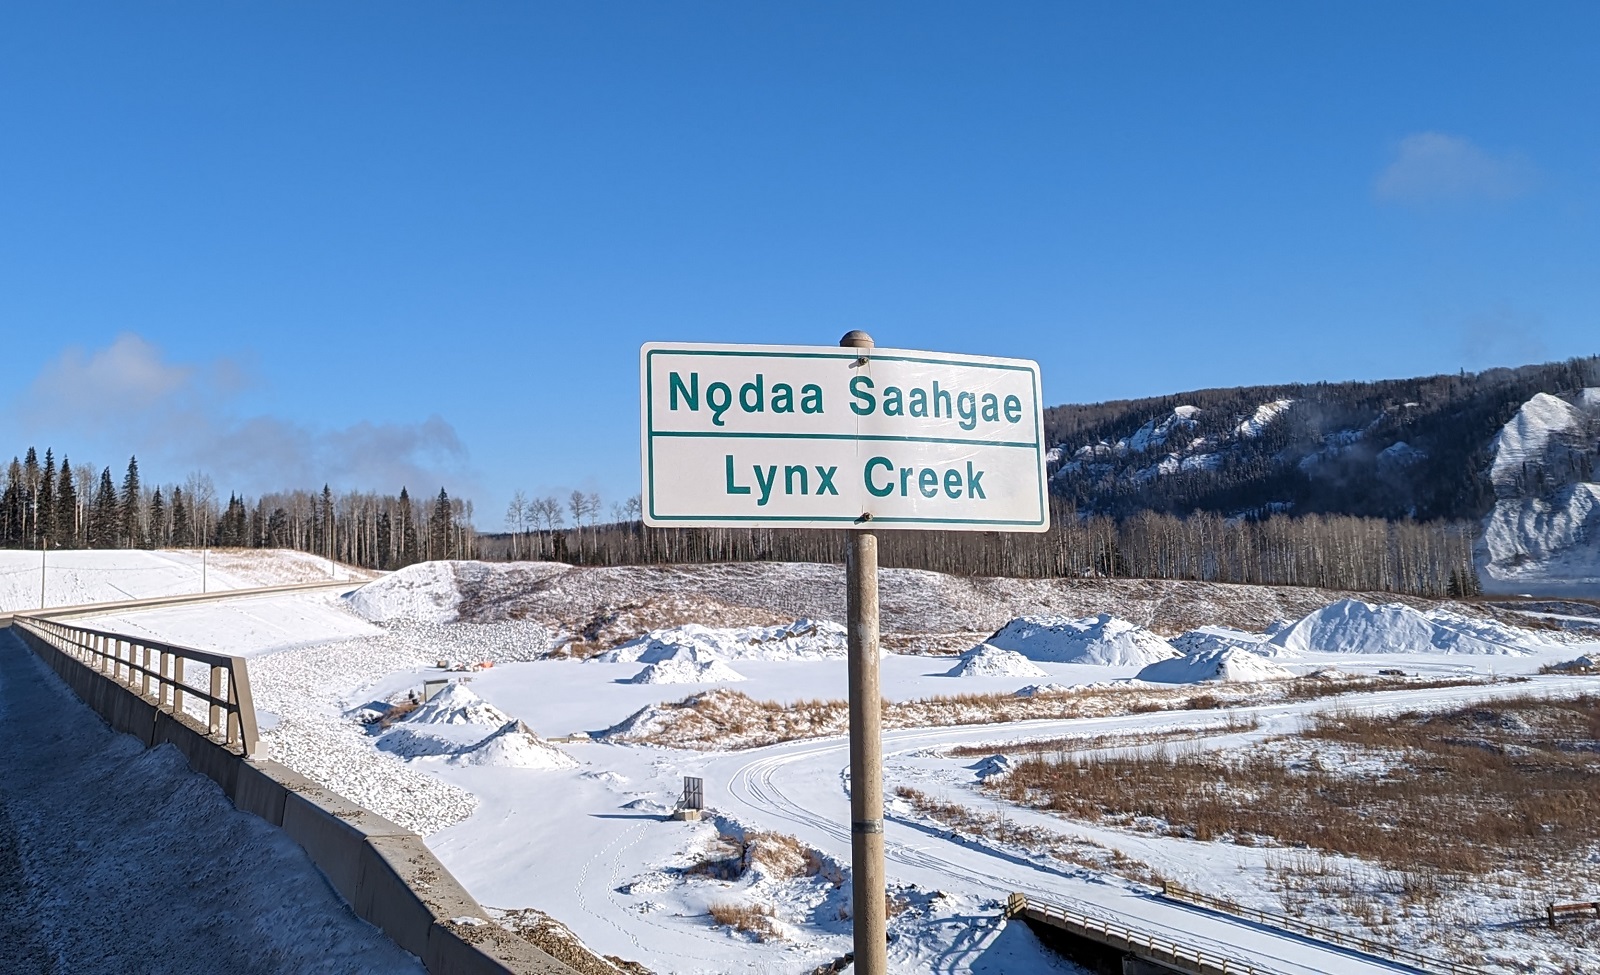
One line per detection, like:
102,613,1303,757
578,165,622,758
1373,131,1536,203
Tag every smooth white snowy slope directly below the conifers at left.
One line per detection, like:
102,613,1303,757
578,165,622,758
0,549,376,613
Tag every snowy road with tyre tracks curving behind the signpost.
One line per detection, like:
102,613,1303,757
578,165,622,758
704,679,1579,975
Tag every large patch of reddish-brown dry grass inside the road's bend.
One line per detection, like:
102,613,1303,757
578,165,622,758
989,696,1600,876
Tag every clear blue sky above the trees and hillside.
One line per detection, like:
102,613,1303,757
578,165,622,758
0,2,1600,528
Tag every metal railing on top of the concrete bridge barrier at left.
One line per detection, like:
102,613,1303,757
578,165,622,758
13,616,258,757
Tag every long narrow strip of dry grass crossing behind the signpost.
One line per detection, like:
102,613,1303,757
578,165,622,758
608,676,1484,751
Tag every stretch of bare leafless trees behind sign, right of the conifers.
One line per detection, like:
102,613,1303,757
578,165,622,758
478,504,1477,597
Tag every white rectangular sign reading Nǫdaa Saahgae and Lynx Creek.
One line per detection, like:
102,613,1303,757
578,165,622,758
640,343,1050,532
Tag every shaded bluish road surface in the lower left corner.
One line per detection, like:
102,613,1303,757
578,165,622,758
0,631,422,975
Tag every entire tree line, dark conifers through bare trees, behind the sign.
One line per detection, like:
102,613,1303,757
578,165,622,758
0,448,1477,597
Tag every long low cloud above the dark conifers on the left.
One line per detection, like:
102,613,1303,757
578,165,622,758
11,333,472,493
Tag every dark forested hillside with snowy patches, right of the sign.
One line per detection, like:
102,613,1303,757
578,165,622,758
1045,357,1600,522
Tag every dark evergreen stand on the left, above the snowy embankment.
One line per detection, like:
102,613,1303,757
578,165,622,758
0,447,478,568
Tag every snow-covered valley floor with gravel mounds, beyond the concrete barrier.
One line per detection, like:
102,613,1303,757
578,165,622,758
65,553,1597,973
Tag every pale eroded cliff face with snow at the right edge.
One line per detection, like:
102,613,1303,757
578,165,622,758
1478,387,1600,596
